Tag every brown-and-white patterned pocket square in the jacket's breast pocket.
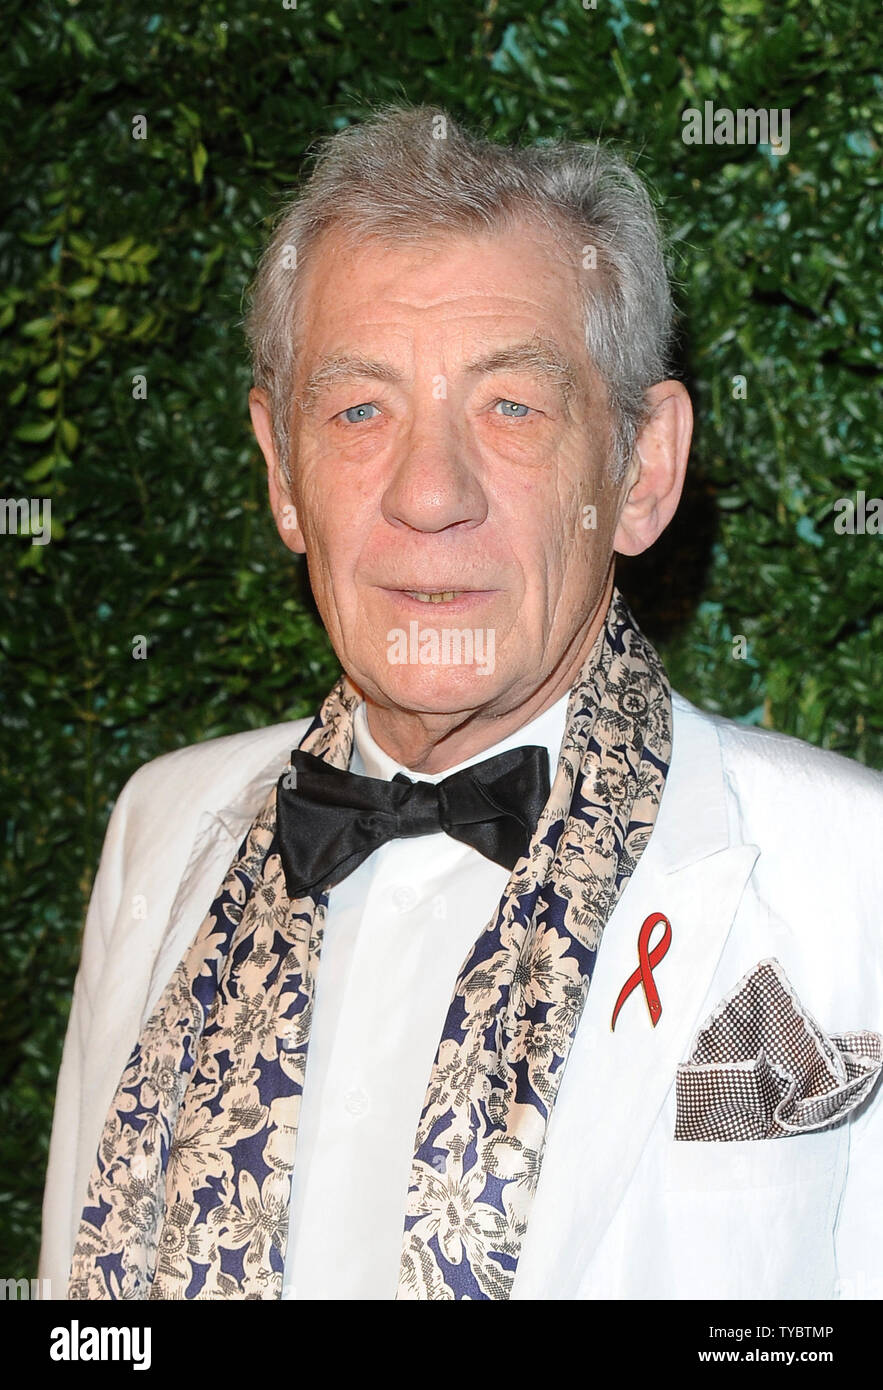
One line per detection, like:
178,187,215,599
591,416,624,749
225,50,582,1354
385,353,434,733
674,960,883,1140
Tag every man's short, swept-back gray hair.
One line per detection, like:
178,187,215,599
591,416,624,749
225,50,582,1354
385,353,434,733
245,106,673,481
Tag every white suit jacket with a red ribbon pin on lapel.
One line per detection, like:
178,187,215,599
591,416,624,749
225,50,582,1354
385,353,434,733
39,695,883,1300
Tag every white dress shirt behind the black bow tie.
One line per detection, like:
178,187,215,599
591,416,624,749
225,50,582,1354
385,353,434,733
282,692,569,1300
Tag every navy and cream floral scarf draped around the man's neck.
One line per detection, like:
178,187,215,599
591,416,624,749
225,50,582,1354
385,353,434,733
70,589,672,1300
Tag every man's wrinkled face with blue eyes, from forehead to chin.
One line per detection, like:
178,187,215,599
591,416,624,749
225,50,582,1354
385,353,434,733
277,225,622,714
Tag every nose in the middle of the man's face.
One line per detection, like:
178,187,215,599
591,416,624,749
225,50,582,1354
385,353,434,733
381,402,488,532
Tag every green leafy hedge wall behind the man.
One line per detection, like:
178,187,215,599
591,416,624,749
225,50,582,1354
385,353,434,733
0,0,883,1276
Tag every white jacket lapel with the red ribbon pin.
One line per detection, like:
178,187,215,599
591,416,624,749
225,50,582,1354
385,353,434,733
512,699,759,1298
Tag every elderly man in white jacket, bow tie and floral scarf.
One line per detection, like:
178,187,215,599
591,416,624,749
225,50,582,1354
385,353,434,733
42,110,883,1300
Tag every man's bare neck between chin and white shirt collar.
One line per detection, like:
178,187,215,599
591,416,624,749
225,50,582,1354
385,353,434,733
364,569,613,773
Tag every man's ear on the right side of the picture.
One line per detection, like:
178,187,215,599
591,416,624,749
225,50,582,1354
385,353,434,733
613,381,692,555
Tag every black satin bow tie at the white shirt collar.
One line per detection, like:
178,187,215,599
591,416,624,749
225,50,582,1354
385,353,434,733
275,745,549,898
